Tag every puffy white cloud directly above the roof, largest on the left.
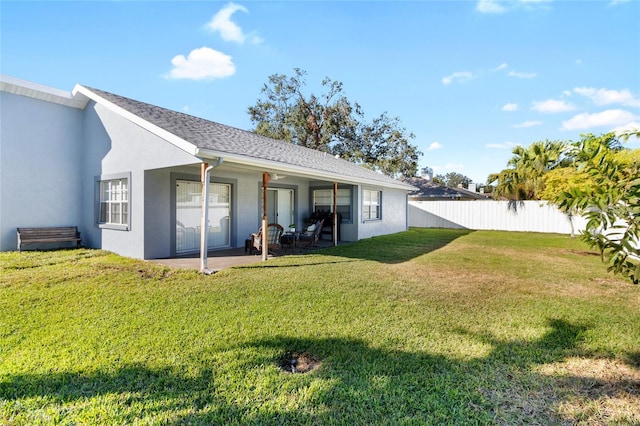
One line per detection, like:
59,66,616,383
166,47,236,80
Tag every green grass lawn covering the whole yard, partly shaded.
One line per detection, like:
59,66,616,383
0,229,640,425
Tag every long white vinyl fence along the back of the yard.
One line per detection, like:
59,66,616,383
409,200,587,235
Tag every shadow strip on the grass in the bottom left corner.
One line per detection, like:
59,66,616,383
0,364,252,424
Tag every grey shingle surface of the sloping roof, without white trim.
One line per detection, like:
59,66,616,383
82,86,413,190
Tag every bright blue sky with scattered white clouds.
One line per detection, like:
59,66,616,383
0,0,640,183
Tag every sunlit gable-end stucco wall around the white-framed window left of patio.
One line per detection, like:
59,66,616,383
82,102,199,258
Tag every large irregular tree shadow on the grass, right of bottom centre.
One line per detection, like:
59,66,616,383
231,319,624,424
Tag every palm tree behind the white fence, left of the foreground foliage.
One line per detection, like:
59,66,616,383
487,140,567,200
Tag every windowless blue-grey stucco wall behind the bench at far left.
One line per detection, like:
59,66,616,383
0,92,85,251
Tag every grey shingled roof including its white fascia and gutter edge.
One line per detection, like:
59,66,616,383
73,85,415,191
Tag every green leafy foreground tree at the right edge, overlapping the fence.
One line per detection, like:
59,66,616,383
549,131,640,284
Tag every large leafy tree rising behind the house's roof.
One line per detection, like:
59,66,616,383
248,68,422,177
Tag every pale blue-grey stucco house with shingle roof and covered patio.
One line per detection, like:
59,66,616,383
0,76,413,259
